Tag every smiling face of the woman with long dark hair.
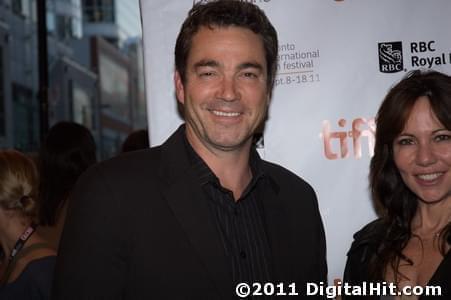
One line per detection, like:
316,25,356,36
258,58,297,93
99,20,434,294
393,96,451,203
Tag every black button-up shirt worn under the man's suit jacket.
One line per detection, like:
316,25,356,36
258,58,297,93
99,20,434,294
185,134,272,284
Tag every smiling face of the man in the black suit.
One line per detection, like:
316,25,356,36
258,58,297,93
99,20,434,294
175,26,269,155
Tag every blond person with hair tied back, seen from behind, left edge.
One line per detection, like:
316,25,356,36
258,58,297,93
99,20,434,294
0,150,56,300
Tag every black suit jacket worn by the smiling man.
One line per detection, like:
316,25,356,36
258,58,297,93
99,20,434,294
53,126,326,300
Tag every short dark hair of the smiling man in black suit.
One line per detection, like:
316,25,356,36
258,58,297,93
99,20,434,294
175,0,278,91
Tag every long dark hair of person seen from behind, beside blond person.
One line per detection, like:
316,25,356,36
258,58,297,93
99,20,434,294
38,121,97,250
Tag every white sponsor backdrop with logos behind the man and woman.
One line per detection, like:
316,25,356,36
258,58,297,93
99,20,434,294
141,0,451,279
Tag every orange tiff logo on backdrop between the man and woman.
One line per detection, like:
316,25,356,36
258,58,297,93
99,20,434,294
320,118,376,160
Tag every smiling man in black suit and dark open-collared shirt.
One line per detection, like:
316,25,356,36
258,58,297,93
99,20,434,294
54,0,326,300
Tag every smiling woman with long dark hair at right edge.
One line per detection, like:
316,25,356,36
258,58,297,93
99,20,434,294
344,70,451,299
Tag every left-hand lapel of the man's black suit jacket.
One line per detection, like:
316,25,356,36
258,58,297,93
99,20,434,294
160,127,234,299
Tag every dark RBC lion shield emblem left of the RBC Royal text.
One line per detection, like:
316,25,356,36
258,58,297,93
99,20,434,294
378,42,404,73
